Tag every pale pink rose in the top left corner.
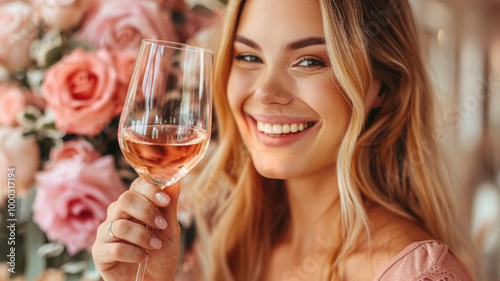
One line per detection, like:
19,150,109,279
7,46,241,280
0,1,38,71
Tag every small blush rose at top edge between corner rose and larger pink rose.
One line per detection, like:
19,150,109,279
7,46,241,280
31,0,89,31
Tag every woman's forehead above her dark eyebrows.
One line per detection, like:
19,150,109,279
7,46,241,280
237,0,323,40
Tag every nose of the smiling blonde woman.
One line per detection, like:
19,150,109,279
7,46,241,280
254,71,293,107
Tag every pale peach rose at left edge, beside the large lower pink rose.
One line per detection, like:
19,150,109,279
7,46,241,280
0,126,41,198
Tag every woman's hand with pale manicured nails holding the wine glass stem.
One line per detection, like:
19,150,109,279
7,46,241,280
92,178,180,281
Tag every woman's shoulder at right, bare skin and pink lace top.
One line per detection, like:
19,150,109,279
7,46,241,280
348,206,473,281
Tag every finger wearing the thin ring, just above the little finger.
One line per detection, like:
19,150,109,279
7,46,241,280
107,219,162,250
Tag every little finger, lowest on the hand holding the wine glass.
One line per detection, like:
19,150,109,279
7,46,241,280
92,242,149,264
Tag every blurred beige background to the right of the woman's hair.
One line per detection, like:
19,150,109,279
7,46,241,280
410,0,500,280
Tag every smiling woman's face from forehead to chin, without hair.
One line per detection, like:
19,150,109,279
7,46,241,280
227,0,350,179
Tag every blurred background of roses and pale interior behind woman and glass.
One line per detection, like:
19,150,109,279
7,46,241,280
0,0,500,281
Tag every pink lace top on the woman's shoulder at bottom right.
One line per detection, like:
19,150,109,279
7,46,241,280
373,240,474,281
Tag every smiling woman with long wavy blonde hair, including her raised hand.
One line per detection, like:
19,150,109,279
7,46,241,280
93,0,477,280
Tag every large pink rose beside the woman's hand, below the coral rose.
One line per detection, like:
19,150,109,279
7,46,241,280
33,155,125,255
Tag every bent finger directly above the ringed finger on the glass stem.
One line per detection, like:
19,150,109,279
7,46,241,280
115,190,168,229
